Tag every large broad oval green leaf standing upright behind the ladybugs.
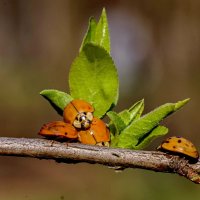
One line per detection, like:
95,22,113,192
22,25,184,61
69,43,119,118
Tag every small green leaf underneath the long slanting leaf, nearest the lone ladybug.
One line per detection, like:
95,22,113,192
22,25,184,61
133,126,168,149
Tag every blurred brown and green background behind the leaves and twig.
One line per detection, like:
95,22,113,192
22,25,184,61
0,0,200,200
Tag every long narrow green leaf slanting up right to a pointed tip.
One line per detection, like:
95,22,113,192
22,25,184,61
117,99,189,148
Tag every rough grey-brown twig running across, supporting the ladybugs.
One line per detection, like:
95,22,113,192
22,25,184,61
0,137,200,184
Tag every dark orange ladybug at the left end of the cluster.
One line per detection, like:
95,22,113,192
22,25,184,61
38,121,78,139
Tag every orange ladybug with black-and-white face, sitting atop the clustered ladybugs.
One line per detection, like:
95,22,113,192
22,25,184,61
63,99,94,129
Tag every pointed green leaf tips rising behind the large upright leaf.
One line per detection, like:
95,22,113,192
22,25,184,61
80,9,110,53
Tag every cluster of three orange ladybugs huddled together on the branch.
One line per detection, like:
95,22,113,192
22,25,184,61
39,99,110,146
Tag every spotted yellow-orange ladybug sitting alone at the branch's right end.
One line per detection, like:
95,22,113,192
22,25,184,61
157,136,199,163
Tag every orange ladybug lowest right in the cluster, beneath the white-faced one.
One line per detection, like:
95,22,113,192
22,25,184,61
78,117,110,146
